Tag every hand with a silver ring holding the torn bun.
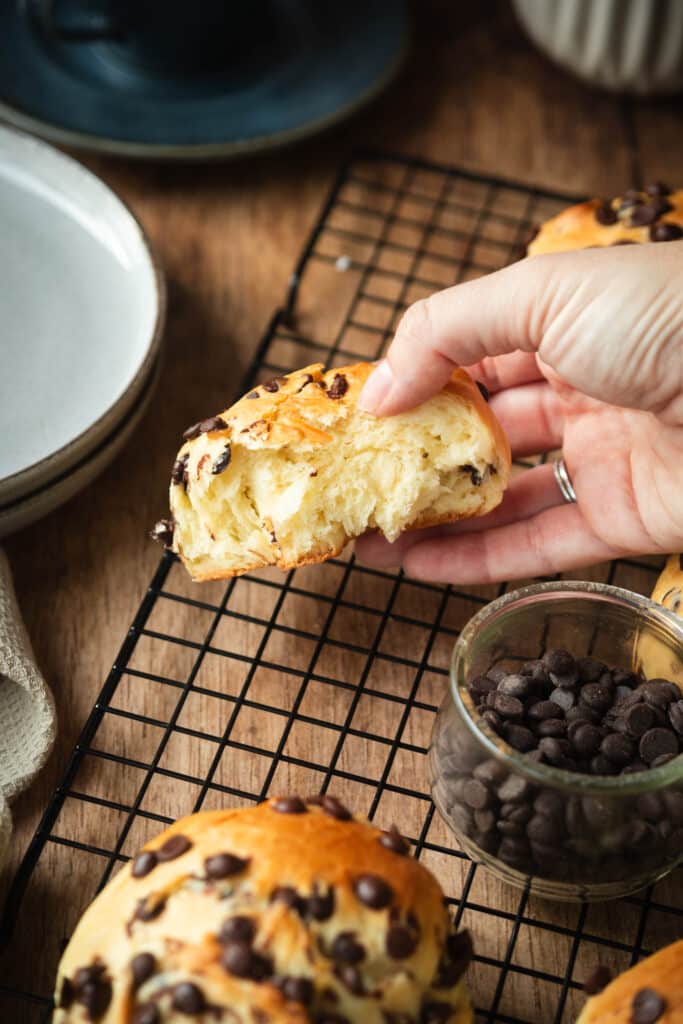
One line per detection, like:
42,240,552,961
356,242,683,584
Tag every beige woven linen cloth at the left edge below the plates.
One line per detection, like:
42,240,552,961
0,548,56,870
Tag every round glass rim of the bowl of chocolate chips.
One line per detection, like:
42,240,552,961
450,580,683,798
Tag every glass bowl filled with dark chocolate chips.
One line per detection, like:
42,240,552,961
429,581,683,900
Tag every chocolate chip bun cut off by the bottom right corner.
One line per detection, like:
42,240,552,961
577,941,683,1024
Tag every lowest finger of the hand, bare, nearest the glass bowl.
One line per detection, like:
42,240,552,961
401,505,623,584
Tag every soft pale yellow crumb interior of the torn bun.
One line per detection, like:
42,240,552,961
176,395,506,574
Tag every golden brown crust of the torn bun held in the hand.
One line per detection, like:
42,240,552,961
163,362,510,581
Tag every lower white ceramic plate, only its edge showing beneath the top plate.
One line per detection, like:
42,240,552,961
0,359,161,539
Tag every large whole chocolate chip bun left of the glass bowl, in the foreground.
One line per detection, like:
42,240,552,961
53,796,472,1024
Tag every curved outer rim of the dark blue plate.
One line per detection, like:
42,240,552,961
0,25,413,159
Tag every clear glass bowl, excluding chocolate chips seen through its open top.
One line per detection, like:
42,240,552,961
429,582,683,900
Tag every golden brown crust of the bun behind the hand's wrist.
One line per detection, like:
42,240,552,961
526,189,683,256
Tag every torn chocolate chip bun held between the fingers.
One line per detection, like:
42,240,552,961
155,362,510,580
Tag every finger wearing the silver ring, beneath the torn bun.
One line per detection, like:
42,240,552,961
355,465,562,568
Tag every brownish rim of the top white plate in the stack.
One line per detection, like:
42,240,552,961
0,121,167,497
